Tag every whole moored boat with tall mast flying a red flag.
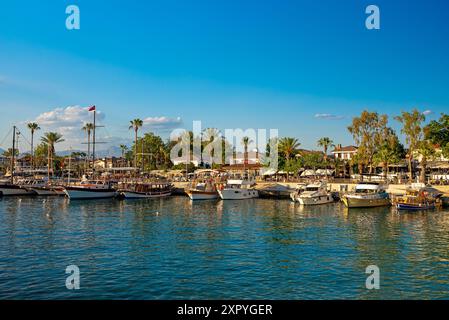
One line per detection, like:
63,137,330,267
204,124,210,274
64,106,117,200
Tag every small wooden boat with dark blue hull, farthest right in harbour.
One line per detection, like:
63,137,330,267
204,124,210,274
394,187,443,211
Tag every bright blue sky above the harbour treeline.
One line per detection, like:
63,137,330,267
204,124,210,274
0,0,449,148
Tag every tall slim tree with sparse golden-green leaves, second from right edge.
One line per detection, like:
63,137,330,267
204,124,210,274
395,109,426,181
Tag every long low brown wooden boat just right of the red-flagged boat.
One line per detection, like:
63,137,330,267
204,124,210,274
118,182,173,199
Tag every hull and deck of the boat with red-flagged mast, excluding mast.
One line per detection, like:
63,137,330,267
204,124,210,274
64,181,117,200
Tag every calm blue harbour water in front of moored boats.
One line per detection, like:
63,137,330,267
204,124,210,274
0,197,449,299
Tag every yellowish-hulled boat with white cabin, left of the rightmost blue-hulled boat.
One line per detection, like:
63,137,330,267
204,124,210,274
341,182,391,208
